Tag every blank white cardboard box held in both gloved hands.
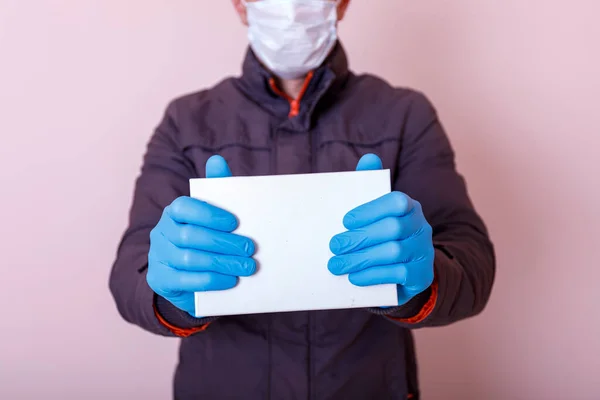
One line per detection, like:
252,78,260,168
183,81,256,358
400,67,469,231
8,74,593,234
190,170,398,317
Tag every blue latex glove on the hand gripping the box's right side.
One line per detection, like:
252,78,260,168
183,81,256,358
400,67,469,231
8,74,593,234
328,154,435,305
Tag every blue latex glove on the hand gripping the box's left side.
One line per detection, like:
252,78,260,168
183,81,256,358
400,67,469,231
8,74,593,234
146,156,256,316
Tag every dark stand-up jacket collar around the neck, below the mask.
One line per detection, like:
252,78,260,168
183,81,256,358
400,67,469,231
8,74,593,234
231,41,350,130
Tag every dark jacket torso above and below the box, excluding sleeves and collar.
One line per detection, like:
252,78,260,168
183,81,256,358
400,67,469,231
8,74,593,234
169,46,418,400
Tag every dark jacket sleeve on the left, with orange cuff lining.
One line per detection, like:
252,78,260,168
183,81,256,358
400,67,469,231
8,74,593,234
109,99,214,337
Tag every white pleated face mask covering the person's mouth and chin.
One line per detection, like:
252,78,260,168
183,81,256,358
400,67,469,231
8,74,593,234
244,0,337,79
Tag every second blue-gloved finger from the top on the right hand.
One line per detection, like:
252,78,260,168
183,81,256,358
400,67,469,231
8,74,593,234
329,213,423,255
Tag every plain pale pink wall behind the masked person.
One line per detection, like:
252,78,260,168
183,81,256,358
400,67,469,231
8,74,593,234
0,0,600,400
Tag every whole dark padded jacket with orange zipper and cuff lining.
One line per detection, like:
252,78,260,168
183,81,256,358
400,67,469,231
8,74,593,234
110,43,495,400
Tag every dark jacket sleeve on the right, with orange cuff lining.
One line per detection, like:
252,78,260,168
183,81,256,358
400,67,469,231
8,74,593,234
371,93,495,328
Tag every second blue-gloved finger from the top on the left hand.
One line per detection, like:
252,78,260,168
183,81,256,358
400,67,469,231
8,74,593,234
162,220,255,257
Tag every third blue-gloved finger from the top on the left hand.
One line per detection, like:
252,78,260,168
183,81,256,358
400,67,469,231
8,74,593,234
168,244,256,276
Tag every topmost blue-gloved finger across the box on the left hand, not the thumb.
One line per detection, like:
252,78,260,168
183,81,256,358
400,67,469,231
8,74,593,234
165,196,238,232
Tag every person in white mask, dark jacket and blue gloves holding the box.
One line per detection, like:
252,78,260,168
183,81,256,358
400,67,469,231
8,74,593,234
110,0,495,399
